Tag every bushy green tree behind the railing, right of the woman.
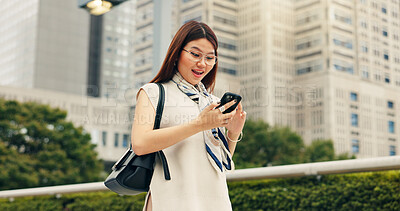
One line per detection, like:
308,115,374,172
233,120,354,169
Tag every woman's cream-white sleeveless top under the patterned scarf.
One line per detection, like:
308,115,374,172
140,81,232,211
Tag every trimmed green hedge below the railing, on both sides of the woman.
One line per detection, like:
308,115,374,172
0,171,400,211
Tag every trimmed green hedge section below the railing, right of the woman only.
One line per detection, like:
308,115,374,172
229,171,400,210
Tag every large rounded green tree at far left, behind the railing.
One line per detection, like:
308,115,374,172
0,99,103,189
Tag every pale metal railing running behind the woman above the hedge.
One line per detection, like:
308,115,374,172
0,156,400,200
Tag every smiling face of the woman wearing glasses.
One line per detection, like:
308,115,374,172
178,38,215,85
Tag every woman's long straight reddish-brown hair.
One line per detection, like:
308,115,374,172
150,21,218,92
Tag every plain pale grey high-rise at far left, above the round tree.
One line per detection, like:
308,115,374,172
0,0,89,94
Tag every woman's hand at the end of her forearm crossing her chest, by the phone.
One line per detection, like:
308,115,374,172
191,101,236,131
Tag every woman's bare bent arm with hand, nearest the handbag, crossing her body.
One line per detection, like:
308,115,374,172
131,90,238,155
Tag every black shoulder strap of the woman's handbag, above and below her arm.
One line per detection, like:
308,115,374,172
153,83,171,180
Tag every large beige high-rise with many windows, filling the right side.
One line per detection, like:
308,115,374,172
239,0,400,158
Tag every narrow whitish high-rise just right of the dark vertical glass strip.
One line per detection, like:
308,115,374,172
95,0,136,100
